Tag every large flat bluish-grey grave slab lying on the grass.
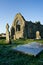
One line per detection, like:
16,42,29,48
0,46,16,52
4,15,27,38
12,42,43,56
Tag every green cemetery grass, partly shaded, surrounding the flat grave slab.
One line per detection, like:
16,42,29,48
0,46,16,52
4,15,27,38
0,39,43,65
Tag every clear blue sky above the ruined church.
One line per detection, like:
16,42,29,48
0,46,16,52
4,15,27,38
0,0,43,33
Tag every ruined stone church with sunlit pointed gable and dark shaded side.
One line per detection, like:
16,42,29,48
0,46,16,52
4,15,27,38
10,13,43,40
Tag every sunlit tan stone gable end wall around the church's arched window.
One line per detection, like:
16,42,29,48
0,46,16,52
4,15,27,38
12,14,25,39
